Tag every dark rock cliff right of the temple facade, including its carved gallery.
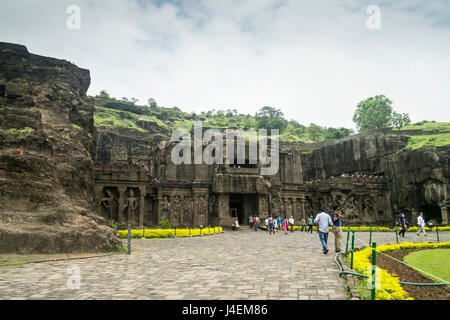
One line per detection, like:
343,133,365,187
302,129,450,224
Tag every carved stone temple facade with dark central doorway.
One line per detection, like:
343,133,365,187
94,143,306,226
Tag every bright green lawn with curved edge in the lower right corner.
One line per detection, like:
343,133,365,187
403,249,450,282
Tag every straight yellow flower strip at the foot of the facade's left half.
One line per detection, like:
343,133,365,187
117,227,223,238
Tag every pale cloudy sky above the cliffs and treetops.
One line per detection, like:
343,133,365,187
0,0,450,128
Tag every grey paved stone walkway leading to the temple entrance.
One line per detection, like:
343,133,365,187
0,230,450,300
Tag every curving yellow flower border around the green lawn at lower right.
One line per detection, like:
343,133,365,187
353,241,450,300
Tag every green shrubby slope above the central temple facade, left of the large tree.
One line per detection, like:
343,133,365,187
94,91,354,142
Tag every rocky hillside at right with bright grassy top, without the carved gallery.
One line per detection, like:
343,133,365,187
302,122,450,224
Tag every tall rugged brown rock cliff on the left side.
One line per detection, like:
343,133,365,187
0,43,120,253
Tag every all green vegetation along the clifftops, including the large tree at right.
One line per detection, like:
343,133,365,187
94,90,450,149
